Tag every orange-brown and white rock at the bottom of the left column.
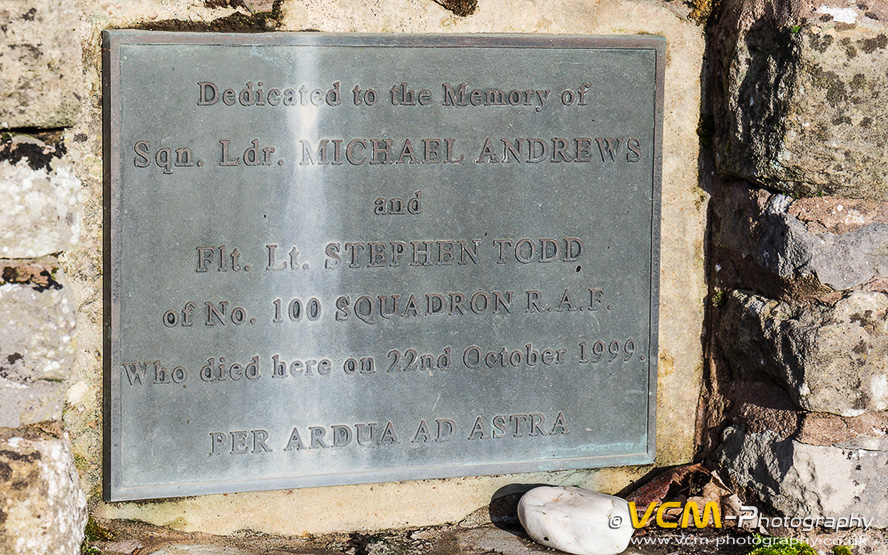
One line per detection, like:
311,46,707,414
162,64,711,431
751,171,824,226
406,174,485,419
0,434,87,555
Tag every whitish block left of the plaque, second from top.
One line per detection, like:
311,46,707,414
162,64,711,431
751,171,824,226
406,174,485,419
0,143,81,258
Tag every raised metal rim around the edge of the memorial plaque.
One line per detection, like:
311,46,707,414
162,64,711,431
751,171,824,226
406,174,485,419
102,30,666,502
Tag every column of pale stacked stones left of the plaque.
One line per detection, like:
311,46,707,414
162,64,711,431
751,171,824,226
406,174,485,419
0,0,86,555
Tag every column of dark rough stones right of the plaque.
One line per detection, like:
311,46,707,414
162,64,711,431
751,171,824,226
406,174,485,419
704,0,888,527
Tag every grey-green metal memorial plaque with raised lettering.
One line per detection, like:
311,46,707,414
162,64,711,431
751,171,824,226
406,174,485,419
104,31,664,500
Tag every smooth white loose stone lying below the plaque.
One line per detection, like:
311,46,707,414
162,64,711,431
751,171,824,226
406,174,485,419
518,486,635,555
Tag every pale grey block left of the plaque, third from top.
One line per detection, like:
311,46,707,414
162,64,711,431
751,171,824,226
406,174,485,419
0,276,76,428
